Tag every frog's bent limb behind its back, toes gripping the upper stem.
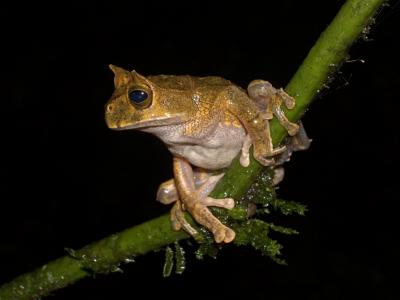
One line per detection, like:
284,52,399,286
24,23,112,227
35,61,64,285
247,80,299,136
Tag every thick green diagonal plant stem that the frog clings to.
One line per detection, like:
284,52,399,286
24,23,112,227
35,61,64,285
0,0,385,300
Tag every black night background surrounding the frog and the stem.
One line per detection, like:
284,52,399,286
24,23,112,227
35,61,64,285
0,0,400,299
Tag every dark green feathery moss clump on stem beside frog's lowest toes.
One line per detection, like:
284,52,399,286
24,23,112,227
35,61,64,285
189,168,306,264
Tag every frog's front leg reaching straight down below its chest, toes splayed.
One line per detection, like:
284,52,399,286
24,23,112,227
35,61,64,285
171,157,235,243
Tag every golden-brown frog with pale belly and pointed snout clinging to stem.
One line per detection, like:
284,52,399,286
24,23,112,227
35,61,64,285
105,65,307,243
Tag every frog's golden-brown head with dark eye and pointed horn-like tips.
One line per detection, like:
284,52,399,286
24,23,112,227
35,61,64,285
105,65,189,130
